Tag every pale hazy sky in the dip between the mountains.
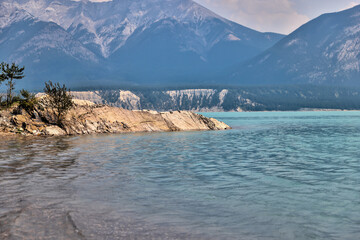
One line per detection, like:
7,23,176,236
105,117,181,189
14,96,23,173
195,0,360,34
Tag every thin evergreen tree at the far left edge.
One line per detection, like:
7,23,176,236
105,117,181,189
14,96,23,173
0,63,25,106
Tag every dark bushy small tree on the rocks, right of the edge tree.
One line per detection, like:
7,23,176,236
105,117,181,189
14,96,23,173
44,81,74,125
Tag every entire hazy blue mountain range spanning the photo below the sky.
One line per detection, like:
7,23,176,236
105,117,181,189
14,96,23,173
0,0,360,89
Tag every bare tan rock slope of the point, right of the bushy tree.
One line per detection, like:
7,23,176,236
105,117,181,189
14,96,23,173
58,106,230,134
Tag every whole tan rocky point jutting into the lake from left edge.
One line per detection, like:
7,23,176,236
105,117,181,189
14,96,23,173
0,100,230,136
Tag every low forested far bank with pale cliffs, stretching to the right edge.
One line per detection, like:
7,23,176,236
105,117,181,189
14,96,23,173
67,85,360,112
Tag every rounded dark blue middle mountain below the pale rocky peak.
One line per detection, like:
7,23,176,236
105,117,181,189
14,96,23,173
109,18,277,85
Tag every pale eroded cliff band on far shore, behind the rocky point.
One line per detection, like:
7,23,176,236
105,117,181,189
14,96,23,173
67,89,259,112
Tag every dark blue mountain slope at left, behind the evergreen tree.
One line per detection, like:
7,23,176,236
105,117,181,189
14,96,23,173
0,5,104,88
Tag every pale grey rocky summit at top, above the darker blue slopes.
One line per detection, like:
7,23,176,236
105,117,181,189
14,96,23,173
5,0,224,58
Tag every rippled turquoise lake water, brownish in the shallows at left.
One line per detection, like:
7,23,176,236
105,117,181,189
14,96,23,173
0,112,360,240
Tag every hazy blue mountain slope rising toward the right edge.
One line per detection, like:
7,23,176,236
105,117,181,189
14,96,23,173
230,6,360,85
